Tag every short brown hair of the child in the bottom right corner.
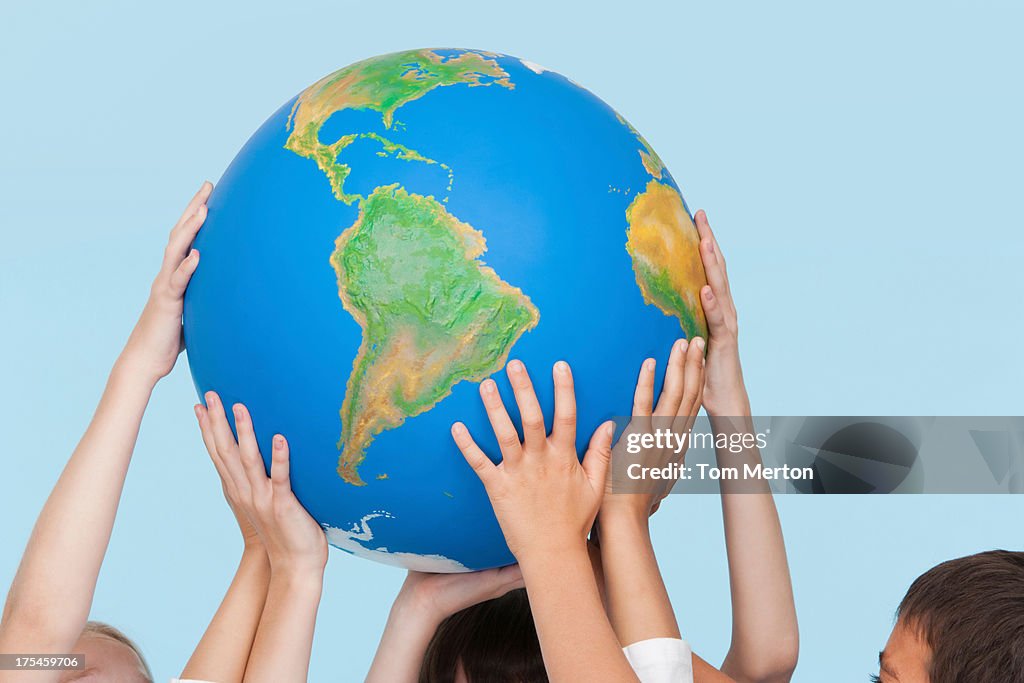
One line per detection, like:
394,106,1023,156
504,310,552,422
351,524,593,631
897,550,1024,683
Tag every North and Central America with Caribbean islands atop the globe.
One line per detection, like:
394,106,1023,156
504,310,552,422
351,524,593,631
285,50,515,204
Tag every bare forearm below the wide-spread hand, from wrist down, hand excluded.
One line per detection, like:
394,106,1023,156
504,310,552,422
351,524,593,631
519,539,637,683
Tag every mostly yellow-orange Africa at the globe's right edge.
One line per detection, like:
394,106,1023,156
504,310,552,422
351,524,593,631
626,179,708,339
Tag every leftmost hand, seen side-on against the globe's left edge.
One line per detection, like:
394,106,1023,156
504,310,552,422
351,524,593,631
122,182,213,381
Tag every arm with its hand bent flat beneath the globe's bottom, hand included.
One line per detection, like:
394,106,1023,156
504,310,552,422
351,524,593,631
367,564,522,683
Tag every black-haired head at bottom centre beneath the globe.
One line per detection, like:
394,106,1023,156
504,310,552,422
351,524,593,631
420,588,548,683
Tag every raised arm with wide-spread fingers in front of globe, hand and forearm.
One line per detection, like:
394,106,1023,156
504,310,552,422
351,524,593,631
452,360,637,683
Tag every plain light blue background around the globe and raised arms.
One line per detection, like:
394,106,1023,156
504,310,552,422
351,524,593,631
0,0,1024,681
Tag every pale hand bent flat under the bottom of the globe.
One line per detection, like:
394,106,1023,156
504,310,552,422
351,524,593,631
395,564,523,624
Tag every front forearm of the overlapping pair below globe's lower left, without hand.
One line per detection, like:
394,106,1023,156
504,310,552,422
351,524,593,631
245,570,324,683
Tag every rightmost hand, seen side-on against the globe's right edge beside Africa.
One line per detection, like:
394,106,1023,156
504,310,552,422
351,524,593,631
694,209,751,418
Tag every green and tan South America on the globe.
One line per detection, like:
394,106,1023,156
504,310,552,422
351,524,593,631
331,184,540,485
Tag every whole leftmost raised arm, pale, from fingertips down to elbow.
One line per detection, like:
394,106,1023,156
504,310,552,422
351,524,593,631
0,183,212,663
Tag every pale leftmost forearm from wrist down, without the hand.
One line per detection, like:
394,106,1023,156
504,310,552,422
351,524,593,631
0,356,156,652
